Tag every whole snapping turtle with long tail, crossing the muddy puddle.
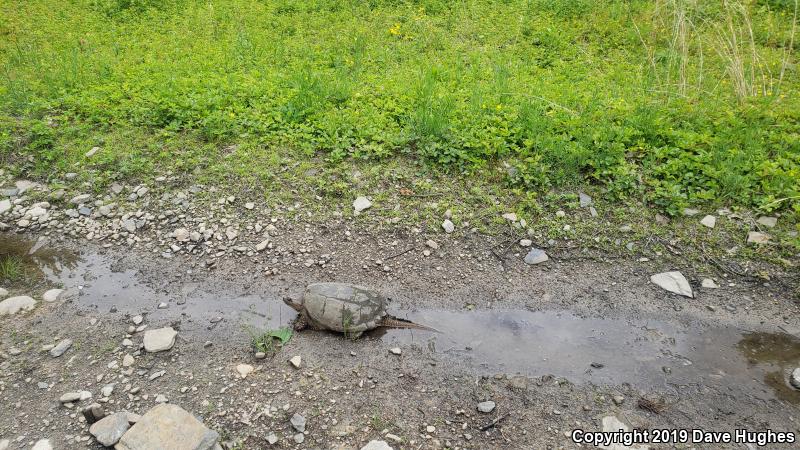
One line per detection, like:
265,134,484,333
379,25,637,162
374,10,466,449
283,283,436,338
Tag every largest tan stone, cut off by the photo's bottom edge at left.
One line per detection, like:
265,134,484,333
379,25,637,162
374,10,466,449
114,403,219,450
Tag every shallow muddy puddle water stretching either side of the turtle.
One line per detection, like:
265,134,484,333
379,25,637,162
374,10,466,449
0,235,800,403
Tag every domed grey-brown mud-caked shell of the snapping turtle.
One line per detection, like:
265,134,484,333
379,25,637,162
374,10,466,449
303,283,386,333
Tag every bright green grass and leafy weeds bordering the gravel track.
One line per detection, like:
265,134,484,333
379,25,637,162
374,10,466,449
0,0,800,218
